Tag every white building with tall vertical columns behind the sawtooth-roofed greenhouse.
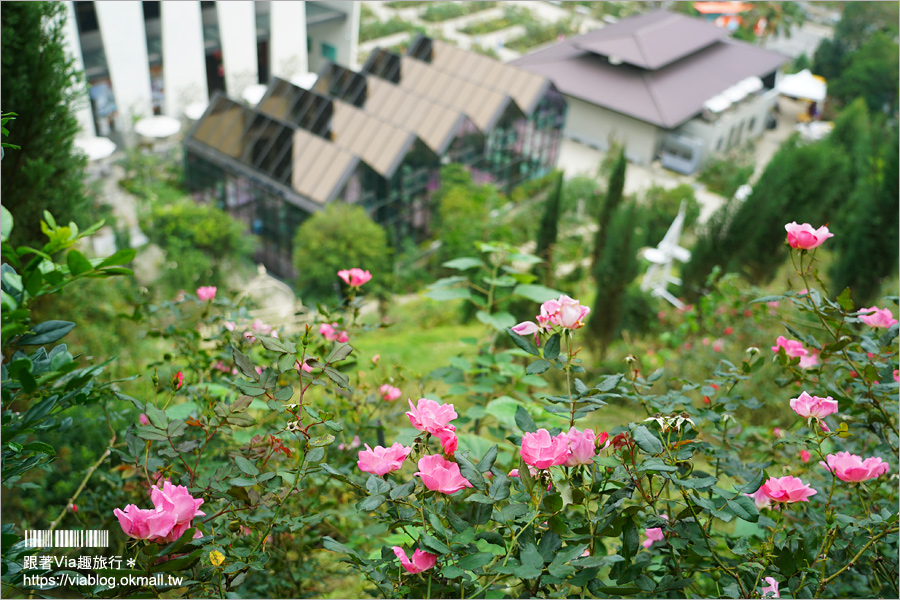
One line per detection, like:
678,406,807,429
65,0,359,135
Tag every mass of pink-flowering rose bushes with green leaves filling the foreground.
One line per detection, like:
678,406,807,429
3,218,898,598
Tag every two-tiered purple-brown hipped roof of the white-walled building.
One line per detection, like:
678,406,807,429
513,11,787,129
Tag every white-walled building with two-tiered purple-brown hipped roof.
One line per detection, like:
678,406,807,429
513,10,786,173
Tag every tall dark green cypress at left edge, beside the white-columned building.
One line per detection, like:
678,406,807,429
0,2,91,247
